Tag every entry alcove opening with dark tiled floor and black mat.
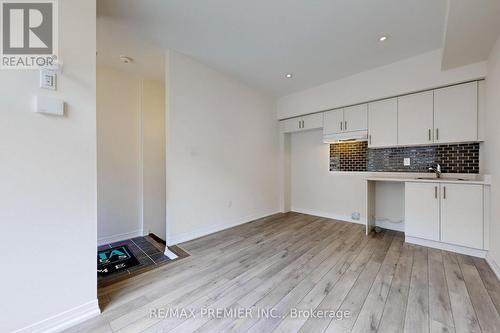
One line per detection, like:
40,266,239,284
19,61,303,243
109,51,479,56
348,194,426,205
96,15,187,300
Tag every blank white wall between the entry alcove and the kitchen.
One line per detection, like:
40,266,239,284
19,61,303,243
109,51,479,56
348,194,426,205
166,52,279,244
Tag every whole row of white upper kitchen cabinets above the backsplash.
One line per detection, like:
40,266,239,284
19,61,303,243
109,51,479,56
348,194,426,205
281,81,485,144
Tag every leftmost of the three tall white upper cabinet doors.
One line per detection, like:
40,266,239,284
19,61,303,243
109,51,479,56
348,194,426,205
368,98,398,148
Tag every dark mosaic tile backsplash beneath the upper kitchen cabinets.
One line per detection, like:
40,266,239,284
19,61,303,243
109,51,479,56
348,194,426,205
330,141,479,173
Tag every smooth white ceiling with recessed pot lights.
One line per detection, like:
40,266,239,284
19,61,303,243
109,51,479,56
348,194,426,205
98,0,446,96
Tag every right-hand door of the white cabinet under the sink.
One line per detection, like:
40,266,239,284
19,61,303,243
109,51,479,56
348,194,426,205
441,184,483,249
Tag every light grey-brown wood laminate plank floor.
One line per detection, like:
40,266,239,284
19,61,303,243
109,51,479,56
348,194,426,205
67,213,500,333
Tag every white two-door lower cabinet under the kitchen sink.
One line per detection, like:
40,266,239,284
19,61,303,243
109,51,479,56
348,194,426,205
405,182,484,249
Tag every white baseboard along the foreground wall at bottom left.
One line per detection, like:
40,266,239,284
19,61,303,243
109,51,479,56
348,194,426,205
14,299,101,333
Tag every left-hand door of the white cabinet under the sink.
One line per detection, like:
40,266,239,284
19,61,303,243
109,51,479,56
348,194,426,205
405,183,439,241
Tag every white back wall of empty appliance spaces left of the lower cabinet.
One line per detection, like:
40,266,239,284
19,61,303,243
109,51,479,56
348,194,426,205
289,130,415,231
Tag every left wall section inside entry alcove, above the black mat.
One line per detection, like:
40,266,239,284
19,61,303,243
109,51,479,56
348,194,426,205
97,66,142,244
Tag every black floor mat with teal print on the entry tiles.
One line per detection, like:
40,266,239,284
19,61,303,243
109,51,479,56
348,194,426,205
97,245,139,276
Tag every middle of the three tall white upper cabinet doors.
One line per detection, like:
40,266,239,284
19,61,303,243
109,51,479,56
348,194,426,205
398,91,434,145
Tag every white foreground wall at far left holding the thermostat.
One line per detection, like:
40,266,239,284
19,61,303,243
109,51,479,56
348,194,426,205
0,0,98,332
